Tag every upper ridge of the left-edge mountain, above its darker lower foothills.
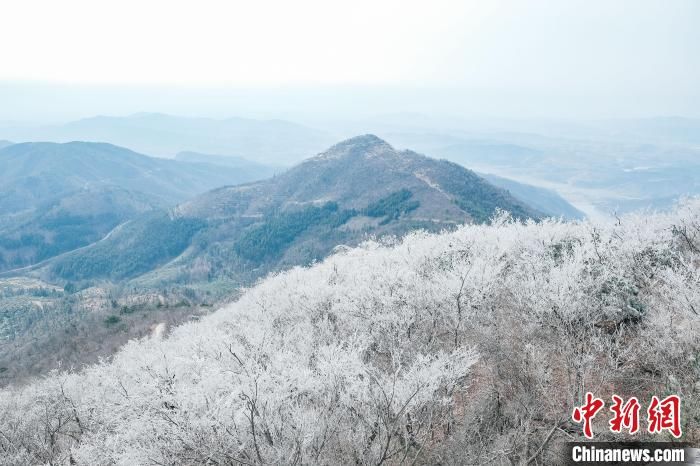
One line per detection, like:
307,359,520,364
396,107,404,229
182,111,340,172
0,141,268,209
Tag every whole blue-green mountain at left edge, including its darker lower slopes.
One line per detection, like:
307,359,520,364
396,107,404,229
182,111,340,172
0,142,270,271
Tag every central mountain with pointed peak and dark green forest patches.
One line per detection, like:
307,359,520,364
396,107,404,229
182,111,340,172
43,135,541,284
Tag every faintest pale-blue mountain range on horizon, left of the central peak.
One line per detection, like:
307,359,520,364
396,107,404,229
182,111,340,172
0,113,333,165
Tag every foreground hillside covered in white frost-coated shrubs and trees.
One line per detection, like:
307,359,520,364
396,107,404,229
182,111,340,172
0,200,700,465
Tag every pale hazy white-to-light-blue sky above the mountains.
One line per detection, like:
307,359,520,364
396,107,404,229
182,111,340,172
0,0,700,119
